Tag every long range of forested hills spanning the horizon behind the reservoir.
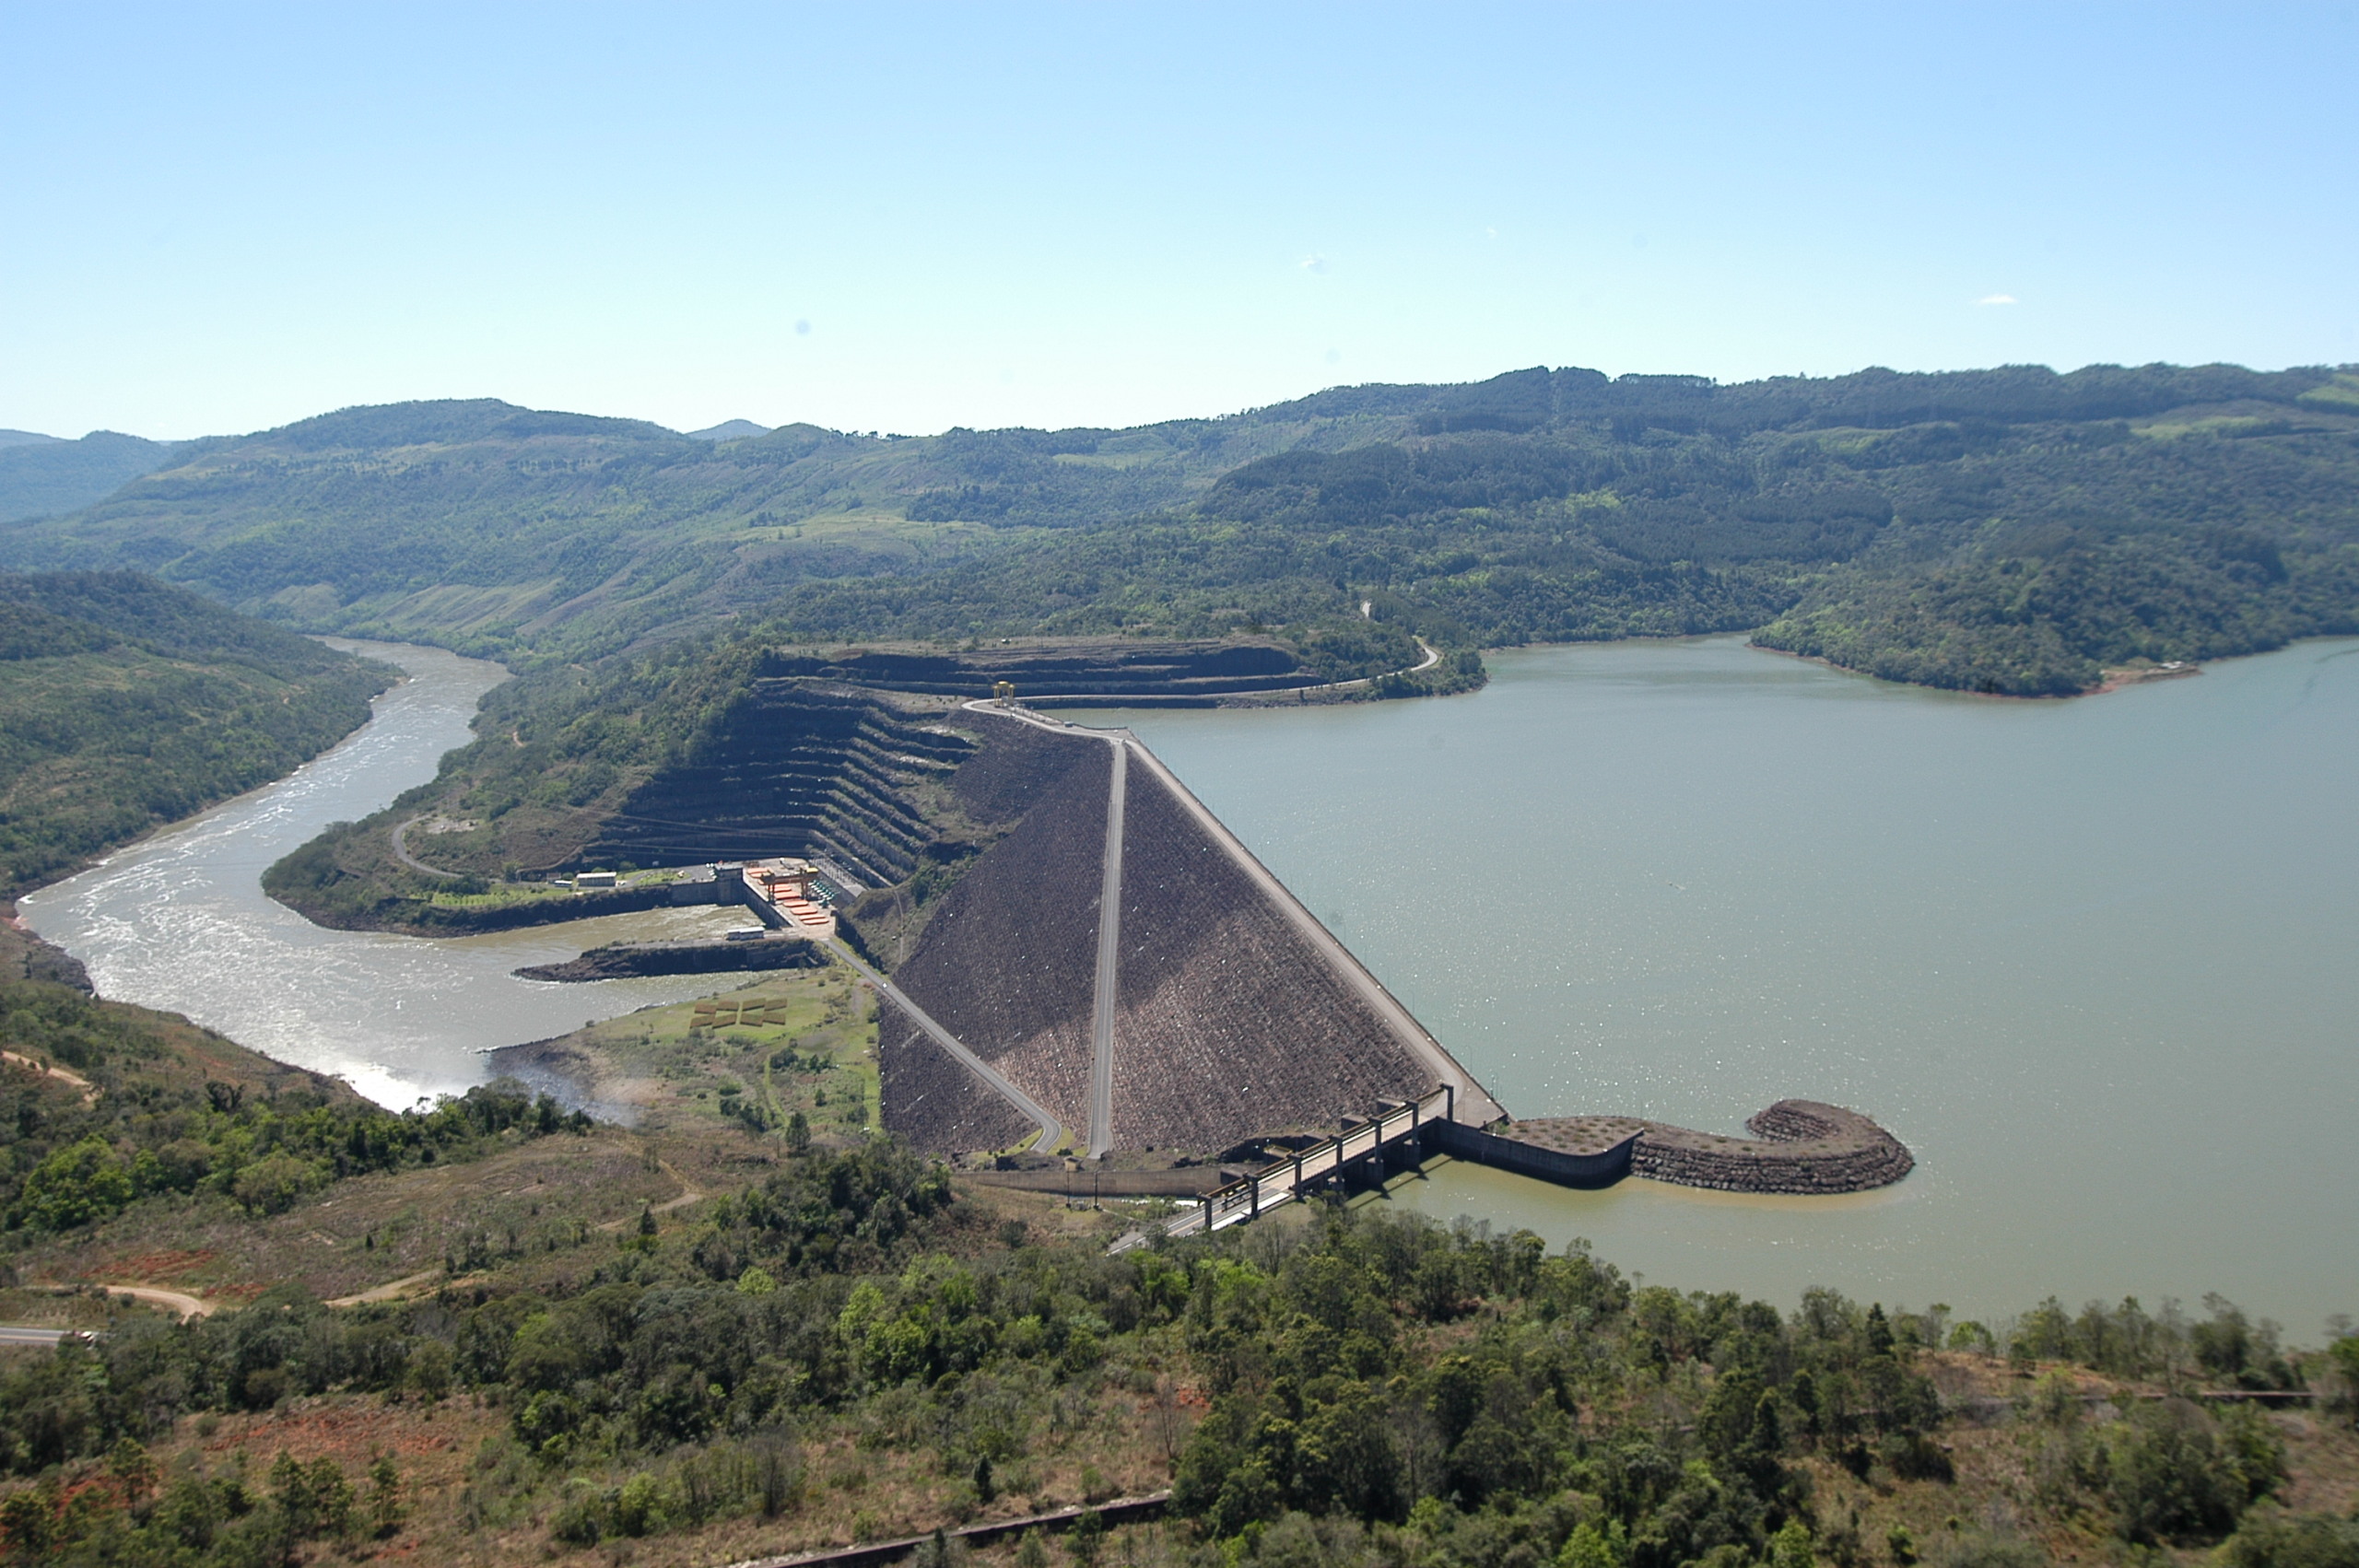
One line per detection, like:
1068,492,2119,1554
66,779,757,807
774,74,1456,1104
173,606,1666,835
0,366,2359,696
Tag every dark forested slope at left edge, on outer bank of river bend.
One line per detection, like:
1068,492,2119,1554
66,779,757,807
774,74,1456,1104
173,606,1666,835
0,570,394,898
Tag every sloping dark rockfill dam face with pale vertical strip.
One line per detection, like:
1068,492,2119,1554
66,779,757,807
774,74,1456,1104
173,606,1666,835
880,708,1498,1153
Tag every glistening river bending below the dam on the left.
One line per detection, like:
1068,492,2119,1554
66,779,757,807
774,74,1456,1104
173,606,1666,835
17,639,738,1106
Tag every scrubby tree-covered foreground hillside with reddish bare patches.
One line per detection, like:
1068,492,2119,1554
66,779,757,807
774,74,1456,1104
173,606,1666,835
0,1027,2359,1568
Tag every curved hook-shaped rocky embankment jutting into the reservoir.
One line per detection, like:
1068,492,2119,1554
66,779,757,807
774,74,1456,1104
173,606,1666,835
1630,1099,1916,1193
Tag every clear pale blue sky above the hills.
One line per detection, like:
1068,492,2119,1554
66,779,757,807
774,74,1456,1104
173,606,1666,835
0,3,2359,436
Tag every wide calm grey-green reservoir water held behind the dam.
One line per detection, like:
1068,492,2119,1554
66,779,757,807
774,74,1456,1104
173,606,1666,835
1074,639,2359,1341
